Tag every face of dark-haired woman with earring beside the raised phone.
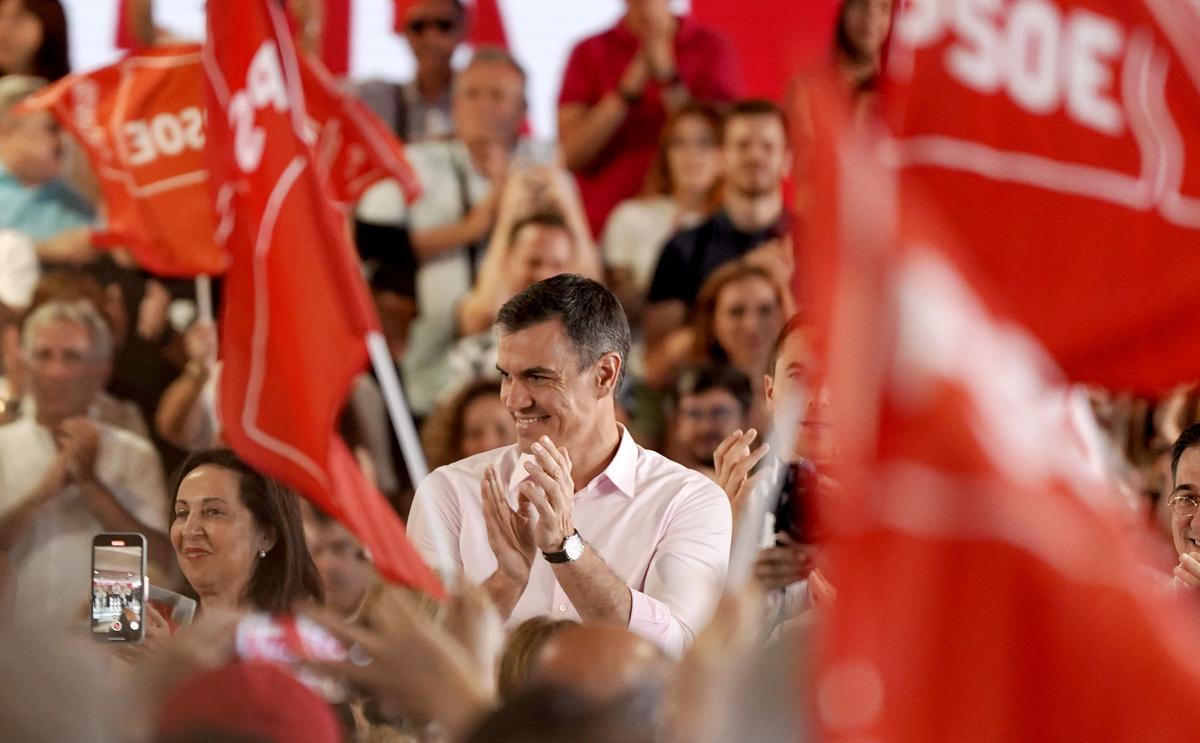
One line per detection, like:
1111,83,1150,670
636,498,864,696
170,465,275,606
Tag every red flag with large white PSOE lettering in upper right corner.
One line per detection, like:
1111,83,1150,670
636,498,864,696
887,0,1200,393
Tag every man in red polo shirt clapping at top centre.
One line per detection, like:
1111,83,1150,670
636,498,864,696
558,0,742,234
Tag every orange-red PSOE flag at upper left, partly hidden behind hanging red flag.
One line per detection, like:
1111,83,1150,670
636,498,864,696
25,44,420,276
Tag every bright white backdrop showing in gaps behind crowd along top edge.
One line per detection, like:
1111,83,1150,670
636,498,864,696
64,0,688,137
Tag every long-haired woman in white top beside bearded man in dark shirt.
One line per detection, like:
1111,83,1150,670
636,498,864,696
600,102,721,324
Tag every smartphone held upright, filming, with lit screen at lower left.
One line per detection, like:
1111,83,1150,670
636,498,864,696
91,534,146,642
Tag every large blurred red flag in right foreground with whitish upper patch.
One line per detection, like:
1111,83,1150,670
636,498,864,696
806,43,1200,743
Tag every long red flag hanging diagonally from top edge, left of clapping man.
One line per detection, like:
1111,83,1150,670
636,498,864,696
204,0,442,595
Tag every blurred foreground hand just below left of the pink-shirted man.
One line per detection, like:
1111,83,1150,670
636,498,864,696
308,591,499,738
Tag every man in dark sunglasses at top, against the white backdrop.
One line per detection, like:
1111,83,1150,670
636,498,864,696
359,0,467,143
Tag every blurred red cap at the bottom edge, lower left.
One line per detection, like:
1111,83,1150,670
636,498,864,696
158,663,342,743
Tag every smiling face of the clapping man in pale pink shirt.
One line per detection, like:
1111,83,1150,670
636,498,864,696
497,319,619,455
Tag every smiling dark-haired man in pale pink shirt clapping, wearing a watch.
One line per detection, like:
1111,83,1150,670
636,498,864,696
408,274,732,654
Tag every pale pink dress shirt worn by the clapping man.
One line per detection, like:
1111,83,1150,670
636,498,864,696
408,429,732,655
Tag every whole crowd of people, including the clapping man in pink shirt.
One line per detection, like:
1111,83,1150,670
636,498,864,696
0,0,1200,742
